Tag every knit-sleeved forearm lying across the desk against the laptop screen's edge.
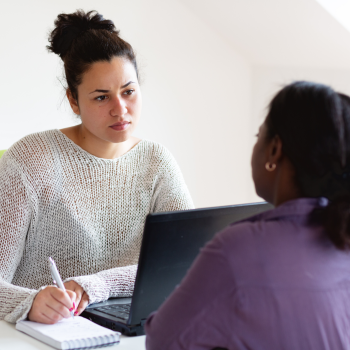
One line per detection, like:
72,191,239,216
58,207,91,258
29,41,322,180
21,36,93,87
64,265,137,303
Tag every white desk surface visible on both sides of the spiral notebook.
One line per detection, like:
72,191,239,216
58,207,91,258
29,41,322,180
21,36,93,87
0,321,146,350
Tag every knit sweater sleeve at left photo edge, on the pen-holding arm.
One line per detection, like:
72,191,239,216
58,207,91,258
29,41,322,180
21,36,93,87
0,152,38,323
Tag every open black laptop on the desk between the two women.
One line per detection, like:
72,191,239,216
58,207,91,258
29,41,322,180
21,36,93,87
82,202,273,335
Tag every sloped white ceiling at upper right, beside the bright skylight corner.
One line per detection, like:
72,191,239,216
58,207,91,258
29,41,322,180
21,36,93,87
179,0,350,69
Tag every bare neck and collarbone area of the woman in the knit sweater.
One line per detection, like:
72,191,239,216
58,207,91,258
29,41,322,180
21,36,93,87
60,124,140,159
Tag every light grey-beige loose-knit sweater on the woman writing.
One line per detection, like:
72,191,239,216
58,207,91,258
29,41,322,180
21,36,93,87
0,130,193,323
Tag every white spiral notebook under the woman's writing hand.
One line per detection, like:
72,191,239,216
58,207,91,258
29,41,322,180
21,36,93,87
16,316,120,350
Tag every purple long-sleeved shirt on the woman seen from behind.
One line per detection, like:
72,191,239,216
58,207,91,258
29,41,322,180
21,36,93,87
145,198,350,350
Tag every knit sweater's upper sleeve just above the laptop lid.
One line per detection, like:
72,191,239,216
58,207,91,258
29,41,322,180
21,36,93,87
151,149,194,213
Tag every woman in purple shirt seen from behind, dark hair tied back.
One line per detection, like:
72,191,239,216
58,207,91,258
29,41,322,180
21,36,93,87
145,82,350,350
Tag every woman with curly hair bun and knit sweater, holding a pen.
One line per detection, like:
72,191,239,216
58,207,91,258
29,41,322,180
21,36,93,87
0,10,193,323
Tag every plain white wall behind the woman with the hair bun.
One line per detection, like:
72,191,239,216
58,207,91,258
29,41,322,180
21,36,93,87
0,0,254,207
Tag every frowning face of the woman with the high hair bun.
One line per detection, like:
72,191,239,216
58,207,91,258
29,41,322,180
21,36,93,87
71,57,142,143
